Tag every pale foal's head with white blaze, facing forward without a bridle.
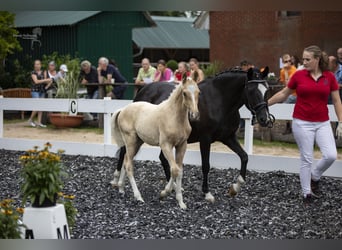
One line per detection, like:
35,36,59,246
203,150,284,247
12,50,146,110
182,77,200,121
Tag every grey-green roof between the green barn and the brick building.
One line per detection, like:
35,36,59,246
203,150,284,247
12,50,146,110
133,16,209,49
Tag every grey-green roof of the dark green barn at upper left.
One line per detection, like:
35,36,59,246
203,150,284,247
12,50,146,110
13,11,100,28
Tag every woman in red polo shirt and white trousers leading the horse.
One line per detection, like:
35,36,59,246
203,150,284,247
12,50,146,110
268,45,342,204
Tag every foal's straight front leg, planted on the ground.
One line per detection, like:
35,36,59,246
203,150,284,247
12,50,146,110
175,141,187,209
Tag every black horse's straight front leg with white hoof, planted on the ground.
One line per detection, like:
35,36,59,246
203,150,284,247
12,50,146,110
200,137,215,203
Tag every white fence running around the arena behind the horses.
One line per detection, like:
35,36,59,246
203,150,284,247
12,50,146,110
0,98,342,177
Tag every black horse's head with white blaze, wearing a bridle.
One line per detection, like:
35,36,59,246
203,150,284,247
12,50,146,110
245,67,274,128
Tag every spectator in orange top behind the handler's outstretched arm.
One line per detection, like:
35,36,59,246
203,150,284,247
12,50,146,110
279,54,297,135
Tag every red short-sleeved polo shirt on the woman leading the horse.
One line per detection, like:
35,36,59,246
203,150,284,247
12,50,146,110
287,69,339,122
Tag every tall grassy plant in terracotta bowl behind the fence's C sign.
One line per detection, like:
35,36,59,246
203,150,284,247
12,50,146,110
49,69,83,128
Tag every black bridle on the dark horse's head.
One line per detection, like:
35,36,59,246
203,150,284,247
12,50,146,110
245,80,275,128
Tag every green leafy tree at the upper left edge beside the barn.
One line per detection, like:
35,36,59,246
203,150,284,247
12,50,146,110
0,11,22,65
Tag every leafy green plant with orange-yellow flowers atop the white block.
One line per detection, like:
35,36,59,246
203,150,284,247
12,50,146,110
20,143,66,205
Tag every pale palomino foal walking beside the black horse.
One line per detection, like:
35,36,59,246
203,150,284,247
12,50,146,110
111,78,200,209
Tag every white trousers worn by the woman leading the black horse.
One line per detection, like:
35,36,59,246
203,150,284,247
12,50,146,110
292,118,337,197
